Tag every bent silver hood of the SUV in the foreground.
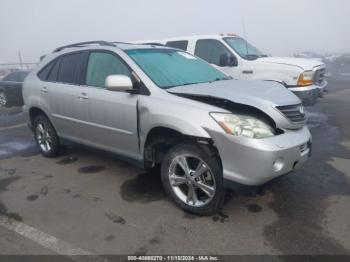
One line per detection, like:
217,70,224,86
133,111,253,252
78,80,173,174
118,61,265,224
168,80,304,129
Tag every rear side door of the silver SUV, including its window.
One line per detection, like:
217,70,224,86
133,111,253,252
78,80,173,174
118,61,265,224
39,52,88,141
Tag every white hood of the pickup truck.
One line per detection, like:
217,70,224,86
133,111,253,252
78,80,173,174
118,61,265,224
256,56,324,71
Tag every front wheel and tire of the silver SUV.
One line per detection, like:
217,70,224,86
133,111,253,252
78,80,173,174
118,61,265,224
161,144,225,215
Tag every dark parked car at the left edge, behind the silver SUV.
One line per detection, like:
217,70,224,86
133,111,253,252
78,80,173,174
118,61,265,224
0,71,29,107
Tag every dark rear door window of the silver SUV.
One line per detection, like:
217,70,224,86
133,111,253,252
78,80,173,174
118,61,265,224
57,53,83,84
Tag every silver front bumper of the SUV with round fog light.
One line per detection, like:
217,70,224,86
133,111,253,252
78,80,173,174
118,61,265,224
207,127,311,188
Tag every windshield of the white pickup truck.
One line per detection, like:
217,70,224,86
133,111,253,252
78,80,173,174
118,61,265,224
223,37,266,60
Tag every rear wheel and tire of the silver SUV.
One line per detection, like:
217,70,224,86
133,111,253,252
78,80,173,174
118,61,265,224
33,115,60,157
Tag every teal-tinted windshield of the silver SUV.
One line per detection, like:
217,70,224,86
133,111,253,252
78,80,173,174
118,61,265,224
125,48,231,89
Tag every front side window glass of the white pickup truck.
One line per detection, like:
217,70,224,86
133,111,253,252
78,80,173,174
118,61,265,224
194,39,232,66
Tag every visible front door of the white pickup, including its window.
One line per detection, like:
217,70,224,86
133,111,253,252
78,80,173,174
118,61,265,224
194,39,240,79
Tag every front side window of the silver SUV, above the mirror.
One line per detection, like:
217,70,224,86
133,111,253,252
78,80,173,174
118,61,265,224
86,52,131,87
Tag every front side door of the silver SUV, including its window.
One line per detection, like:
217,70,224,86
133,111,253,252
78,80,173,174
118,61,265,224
82,50,139,158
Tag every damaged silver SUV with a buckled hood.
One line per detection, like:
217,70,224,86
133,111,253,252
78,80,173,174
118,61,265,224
23,41,311,214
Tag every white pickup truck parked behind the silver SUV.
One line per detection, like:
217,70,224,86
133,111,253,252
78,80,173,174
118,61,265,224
136,34,327,105
